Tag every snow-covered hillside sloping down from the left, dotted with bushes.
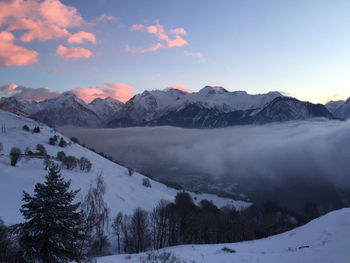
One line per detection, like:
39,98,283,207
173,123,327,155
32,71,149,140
0,110,249,225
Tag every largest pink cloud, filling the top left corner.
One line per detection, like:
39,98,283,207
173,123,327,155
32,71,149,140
0,0,96,43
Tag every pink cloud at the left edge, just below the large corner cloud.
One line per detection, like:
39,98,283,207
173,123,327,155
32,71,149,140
0,31,39,67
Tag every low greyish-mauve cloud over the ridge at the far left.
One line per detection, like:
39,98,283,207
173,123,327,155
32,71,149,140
0,83,59,101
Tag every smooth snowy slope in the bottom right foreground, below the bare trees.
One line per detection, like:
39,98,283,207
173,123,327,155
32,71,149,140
97,208,350,263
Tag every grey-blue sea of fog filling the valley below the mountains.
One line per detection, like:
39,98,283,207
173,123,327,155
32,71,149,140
59,119,350,213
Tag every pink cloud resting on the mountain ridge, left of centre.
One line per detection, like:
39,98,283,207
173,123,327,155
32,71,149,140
71,82,134,103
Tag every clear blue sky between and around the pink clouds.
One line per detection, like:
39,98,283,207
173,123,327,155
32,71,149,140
0,0,350,103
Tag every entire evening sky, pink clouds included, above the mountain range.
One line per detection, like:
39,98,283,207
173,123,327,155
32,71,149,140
0,0,350,103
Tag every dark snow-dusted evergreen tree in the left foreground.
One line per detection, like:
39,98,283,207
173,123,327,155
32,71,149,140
19,165,82,263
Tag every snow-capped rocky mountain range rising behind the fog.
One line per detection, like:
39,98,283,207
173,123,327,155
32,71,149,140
0,86,340,128
